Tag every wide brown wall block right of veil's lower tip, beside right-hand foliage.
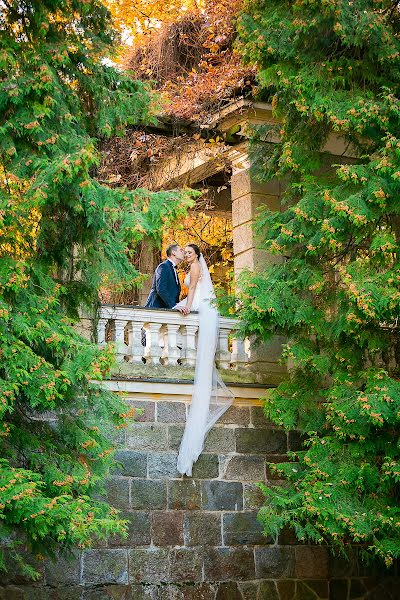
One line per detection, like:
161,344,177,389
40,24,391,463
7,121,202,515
235,428,287,454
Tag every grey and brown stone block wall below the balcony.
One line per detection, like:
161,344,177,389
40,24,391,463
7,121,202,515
0,386,400,600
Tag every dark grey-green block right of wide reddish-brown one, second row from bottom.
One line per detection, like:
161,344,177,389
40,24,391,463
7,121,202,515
255,546,295,579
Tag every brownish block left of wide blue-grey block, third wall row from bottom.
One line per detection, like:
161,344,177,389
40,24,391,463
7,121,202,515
183,511,222,546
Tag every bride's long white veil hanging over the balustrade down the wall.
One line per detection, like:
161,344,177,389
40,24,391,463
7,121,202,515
177,254,234,476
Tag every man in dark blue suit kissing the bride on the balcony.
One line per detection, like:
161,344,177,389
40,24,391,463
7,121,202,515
145,244,185,310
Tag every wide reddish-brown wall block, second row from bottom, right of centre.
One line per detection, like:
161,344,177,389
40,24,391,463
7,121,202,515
204,548,255,581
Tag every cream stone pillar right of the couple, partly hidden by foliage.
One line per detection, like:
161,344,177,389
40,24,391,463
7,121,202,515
231,152,286,383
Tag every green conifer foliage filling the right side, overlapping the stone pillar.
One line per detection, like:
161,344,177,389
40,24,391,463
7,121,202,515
238,0,400,566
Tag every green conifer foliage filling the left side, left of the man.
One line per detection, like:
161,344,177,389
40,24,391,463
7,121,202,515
0,0,191,576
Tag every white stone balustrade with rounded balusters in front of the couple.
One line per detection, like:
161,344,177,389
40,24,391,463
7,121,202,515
97,304,249,370
